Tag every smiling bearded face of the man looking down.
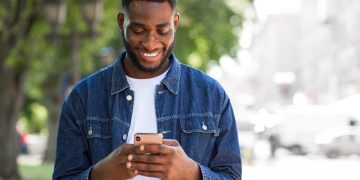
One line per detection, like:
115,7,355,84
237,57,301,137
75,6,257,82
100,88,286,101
118,1,179,74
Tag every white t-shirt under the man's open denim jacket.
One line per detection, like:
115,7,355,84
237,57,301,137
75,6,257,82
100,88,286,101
126,71,167,180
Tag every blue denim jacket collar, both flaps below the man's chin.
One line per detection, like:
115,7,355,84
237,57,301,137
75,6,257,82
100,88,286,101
111,51,181,95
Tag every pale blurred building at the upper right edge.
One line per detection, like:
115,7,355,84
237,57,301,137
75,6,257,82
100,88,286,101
297,0,360,103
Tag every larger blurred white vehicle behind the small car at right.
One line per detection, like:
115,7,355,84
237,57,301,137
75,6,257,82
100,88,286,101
277,105,351,155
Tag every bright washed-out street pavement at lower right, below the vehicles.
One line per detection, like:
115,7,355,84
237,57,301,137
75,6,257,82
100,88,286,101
243,153,360,180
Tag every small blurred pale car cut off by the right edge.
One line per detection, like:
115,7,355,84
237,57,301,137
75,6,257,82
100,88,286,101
316,131,360,158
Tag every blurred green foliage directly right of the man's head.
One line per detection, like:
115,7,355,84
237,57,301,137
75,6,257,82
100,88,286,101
175,0,242,69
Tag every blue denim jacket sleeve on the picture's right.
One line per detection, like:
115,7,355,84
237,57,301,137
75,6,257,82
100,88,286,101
199,98,242,180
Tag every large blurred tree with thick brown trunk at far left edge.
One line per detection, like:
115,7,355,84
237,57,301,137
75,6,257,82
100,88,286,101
0,0,46,179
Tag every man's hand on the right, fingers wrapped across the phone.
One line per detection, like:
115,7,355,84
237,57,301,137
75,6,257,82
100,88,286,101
128,140,201,180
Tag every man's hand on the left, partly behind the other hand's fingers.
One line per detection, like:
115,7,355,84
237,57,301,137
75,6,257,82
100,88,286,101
90,144,137,180
